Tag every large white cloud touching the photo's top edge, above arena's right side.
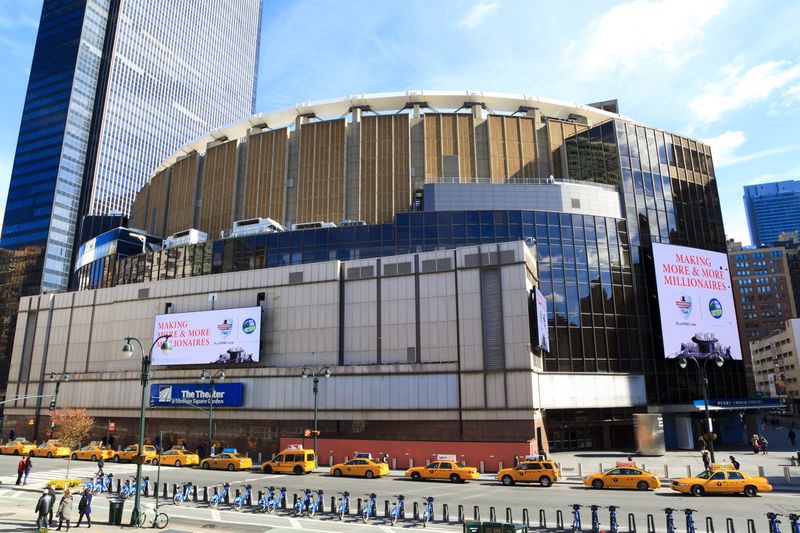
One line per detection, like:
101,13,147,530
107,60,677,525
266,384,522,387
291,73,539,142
569,0,727,79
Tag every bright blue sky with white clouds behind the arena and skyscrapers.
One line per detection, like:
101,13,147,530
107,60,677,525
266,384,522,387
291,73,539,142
0,0,800,242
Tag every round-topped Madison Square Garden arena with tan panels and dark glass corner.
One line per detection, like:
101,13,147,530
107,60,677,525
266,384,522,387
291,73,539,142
6,92,746,467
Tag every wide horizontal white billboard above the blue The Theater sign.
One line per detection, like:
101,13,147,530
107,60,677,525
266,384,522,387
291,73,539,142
152,307,261,365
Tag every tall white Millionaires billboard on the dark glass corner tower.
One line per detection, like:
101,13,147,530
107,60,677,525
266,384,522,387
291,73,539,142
653,243,742,360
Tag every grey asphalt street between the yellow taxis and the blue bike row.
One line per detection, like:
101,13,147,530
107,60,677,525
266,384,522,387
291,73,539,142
0,450,800,531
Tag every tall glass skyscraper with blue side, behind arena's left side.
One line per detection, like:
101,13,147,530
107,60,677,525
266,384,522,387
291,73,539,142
0,0,261,292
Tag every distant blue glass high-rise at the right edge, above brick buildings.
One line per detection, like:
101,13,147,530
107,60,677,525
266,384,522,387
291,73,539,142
744,181,800,246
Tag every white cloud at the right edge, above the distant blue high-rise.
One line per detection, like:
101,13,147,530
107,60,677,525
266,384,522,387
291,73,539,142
689,60,800,123
